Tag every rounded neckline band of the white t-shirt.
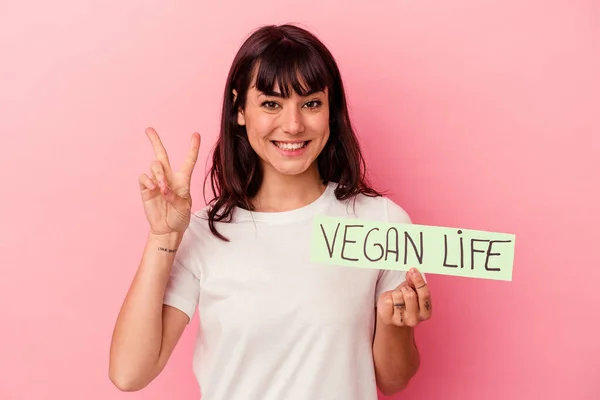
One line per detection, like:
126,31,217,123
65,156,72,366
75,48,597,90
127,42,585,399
233,182,337,223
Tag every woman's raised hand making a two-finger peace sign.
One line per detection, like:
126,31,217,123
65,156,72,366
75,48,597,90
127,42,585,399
139,128,200,235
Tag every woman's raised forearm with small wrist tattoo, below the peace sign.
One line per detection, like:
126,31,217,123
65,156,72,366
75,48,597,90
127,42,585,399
109,231,181,386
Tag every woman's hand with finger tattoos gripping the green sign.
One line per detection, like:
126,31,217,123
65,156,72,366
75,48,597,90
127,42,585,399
377,268,431,327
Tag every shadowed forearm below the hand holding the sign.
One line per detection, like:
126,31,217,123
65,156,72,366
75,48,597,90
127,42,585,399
373,315,420,395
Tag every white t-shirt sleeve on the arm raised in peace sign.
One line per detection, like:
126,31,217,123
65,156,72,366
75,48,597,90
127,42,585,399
163,228,200,320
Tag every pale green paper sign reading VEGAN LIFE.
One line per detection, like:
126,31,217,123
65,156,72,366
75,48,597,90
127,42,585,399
311,217,515,281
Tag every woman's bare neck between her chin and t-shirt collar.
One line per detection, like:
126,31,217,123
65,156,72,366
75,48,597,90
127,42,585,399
252,166,326,212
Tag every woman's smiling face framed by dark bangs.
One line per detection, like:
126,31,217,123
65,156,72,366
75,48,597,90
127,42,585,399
238,79,329,179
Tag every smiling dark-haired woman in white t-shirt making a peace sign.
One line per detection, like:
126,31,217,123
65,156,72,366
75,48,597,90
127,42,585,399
109,25,431,400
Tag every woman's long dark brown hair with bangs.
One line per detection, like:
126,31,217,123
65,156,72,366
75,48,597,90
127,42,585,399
204,24,380,241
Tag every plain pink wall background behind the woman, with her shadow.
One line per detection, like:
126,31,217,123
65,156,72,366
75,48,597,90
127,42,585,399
0,0,600,400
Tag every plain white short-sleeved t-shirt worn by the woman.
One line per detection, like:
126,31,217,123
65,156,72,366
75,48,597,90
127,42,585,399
164,183,410,400
